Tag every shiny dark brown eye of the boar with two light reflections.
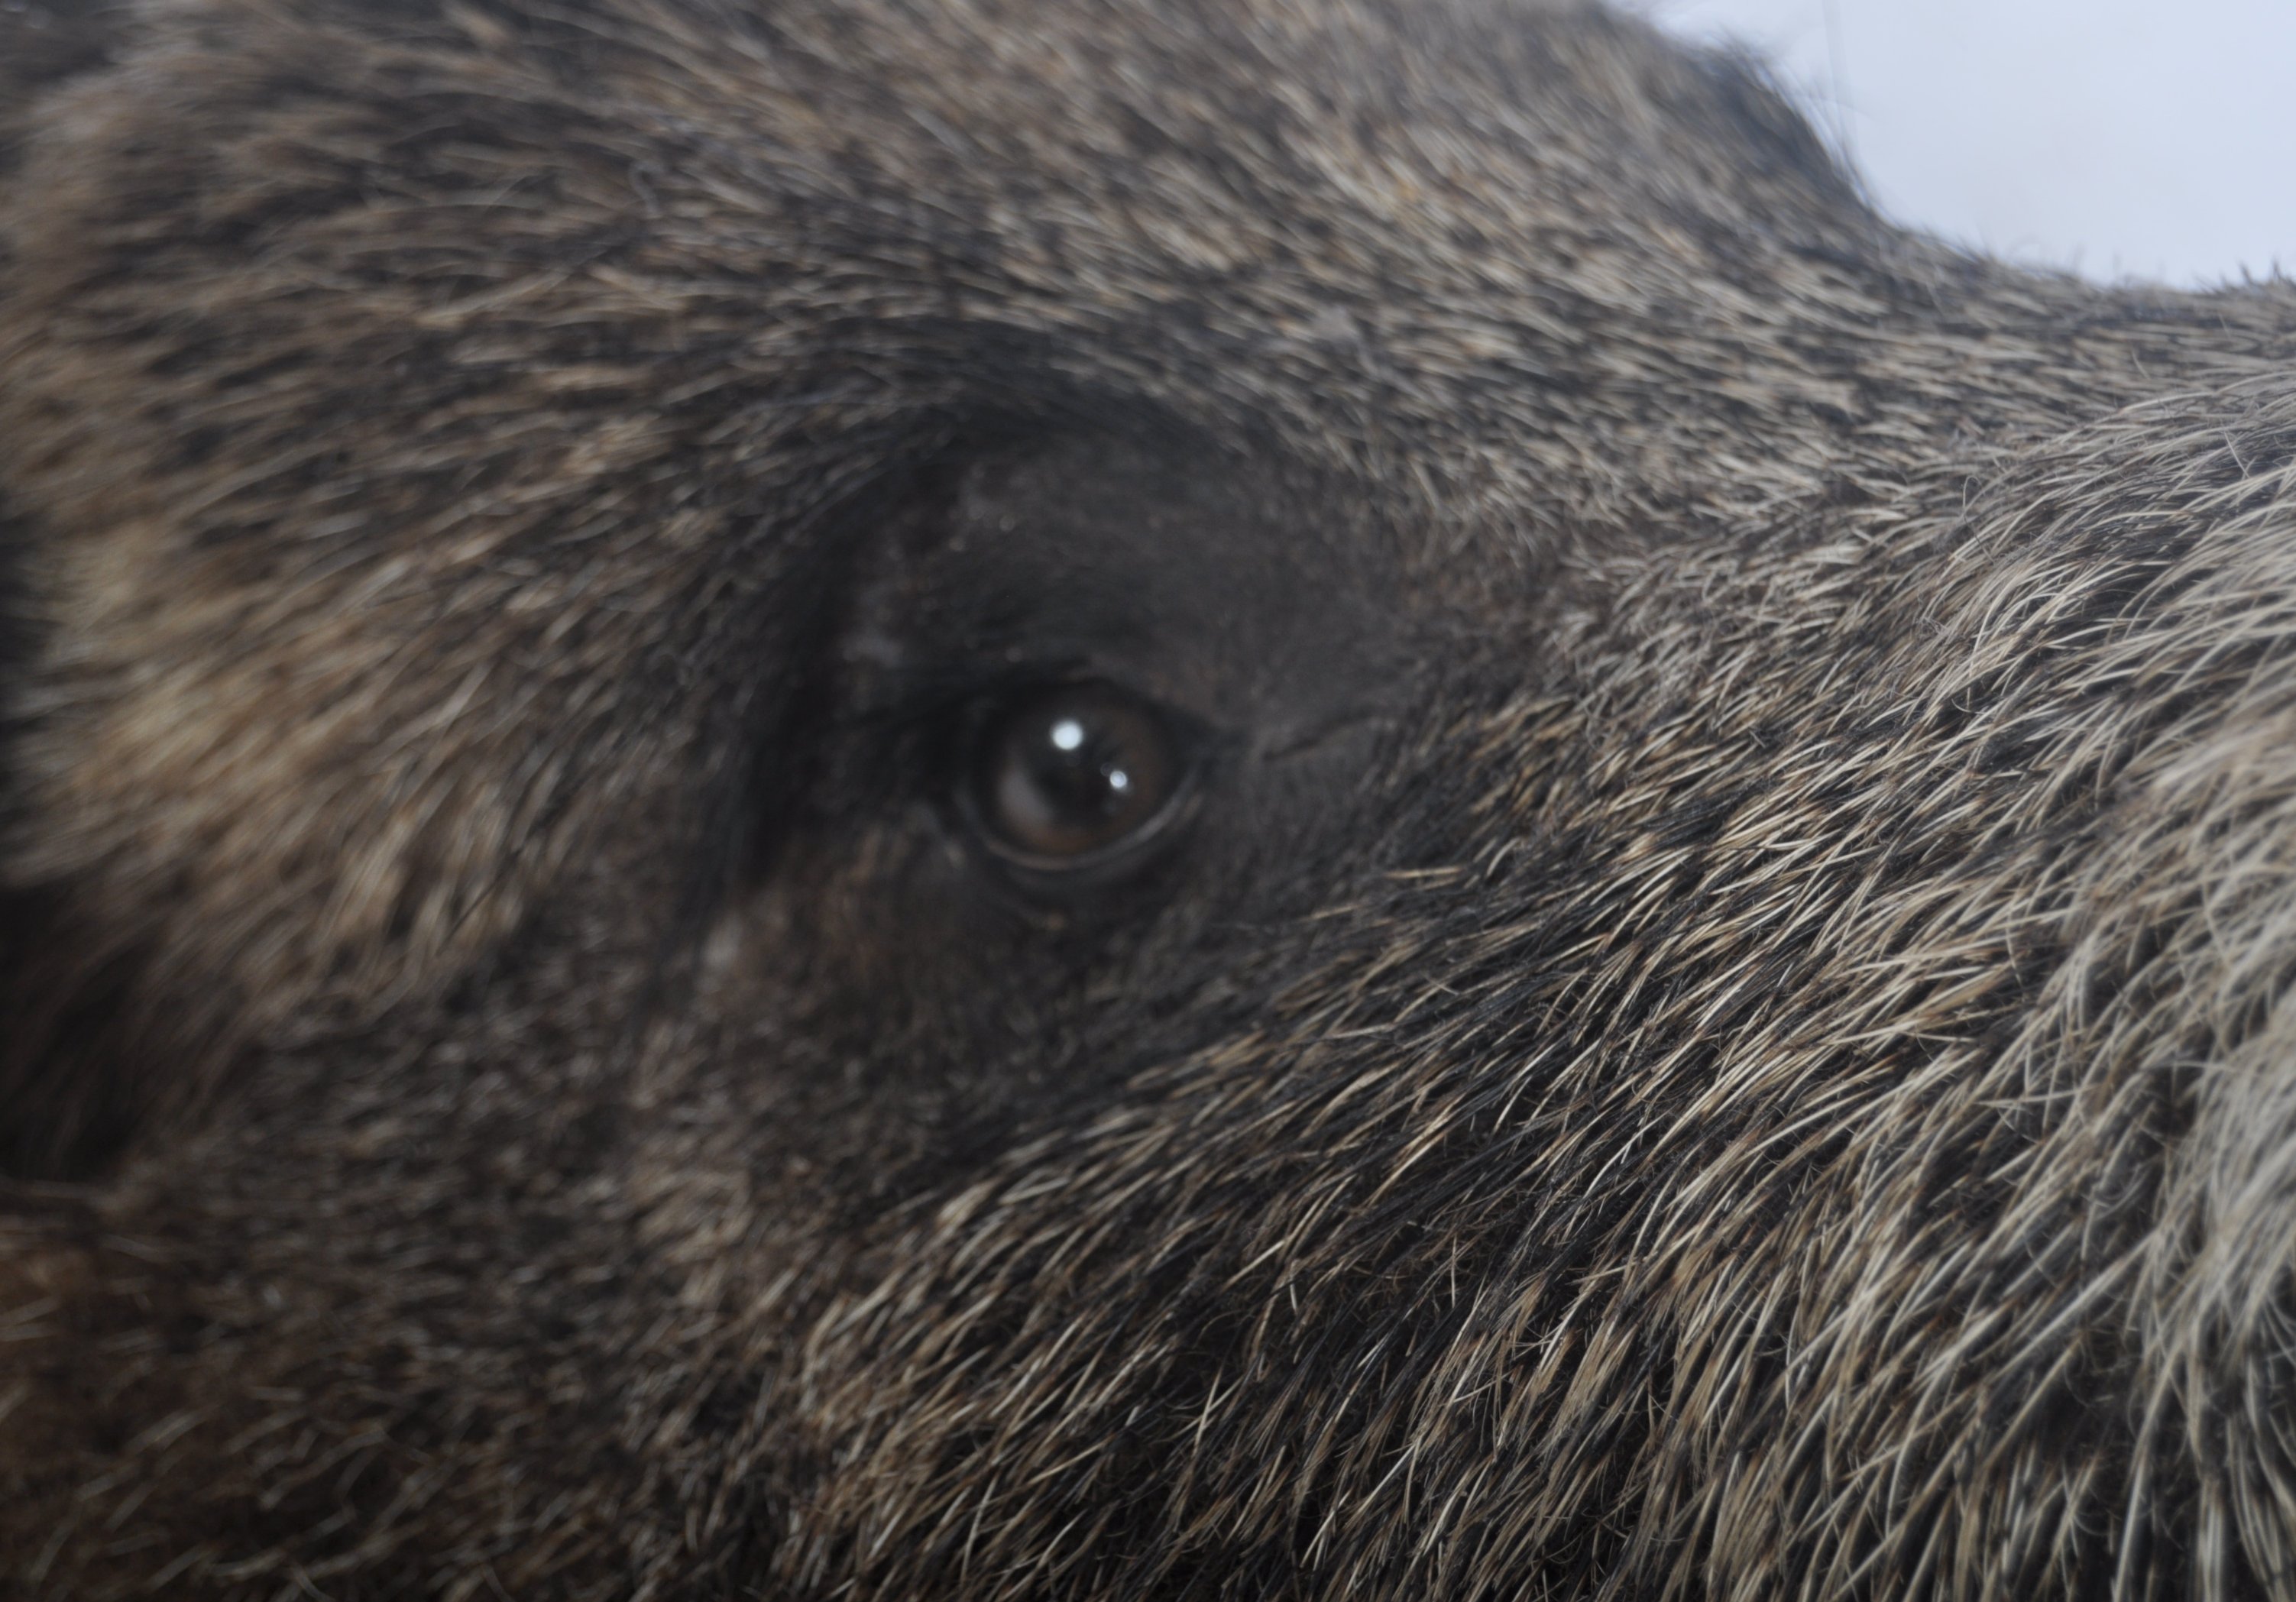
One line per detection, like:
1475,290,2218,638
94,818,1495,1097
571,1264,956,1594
964,684,1187,872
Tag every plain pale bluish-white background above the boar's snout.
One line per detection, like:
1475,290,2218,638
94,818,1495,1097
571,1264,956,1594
1642,0,2296,285
